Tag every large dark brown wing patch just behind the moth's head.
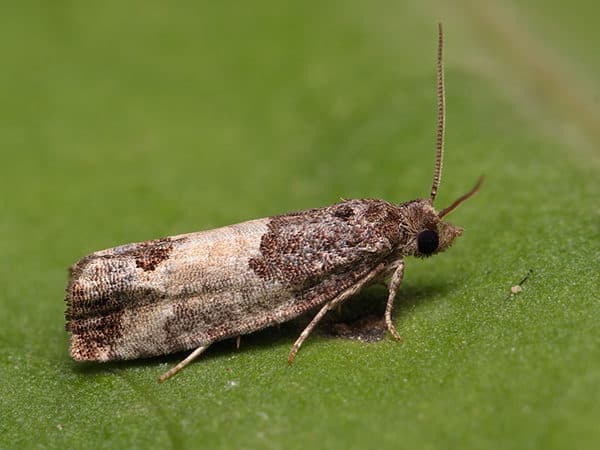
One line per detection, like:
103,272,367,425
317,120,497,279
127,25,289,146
249,199,401,288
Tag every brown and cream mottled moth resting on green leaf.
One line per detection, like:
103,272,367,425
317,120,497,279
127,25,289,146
66,24,482,382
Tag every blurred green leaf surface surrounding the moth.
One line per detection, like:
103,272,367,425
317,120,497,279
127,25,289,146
0,0,600,449
